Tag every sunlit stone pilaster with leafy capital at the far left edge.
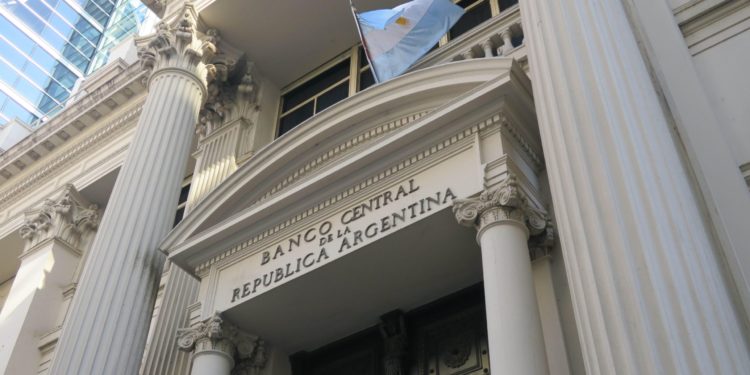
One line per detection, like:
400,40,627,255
0,185,99,374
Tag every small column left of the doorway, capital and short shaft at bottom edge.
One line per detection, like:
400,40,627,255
177,313,267,375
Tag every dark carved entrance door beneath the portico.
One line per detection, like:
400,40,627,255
291,284,489,375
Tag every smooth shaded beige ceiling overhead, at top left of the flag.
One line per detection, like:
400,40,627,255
200,0,403,87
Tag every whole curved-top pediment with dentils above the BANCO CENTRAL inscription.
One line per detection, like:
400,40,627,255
162,58,533,270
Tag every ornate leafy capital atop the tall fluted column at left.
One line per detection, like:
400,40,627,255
138,2,216,86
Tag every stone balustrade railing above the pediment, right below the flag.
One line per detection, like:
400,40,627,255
410,5,526,70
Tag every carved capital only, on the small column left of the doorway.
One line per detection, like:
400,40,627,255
177,312,267,375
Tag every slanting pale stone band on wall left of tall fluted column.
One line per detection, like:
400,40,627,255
0,102,143,209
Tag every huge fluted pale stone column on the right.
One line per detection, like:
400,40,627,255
520,0,750,374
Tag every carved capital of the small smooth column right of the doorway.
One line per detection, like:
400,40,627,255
453,174,549,236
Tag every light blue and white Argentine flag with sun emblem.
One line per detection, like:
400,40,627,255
354,0,464,82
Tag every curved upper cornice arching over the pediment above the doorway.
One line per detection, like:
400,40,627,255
162,59,530,251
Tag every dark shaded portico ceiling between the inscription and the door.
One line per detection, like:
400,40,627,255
224,209,482,354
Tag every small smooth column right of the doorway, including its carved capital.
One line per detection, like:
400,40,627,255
453,174,549,375
